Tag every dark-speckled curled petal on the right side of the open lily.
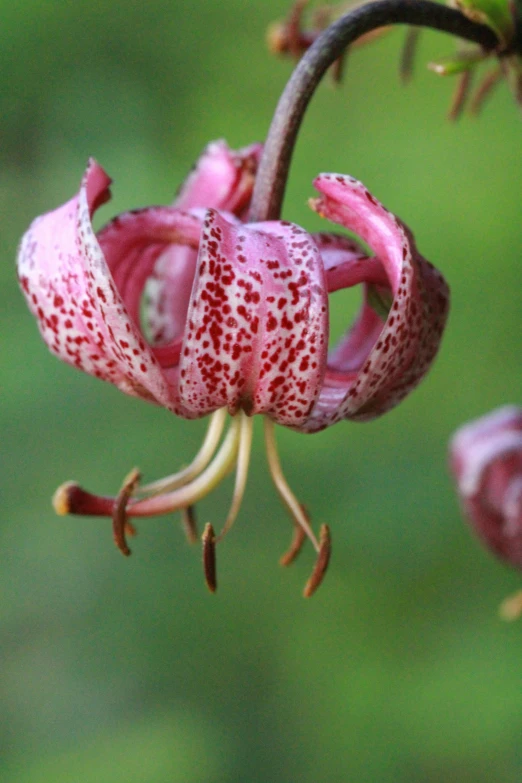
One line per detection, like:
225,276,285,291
305,174,449,431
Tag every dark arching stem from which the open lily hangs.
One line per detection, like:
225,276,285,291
249,0,498,221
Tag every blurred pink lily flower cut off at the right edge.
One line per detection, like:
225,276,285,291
450,405,522,568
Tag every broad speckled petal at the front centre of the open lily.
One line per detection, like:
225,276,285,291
180,210,328,428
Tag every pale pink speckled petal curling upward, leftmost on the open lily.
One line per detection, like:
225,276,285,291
18,160,174,407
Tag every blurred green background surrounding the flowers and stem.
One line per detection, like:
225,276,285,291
4,0,522,783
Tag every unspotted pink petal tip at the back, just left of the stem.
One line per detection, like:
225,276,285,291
174,139,263,217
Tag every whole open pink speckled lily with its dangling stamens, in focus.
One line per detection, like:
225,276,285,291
18,142,449,595
